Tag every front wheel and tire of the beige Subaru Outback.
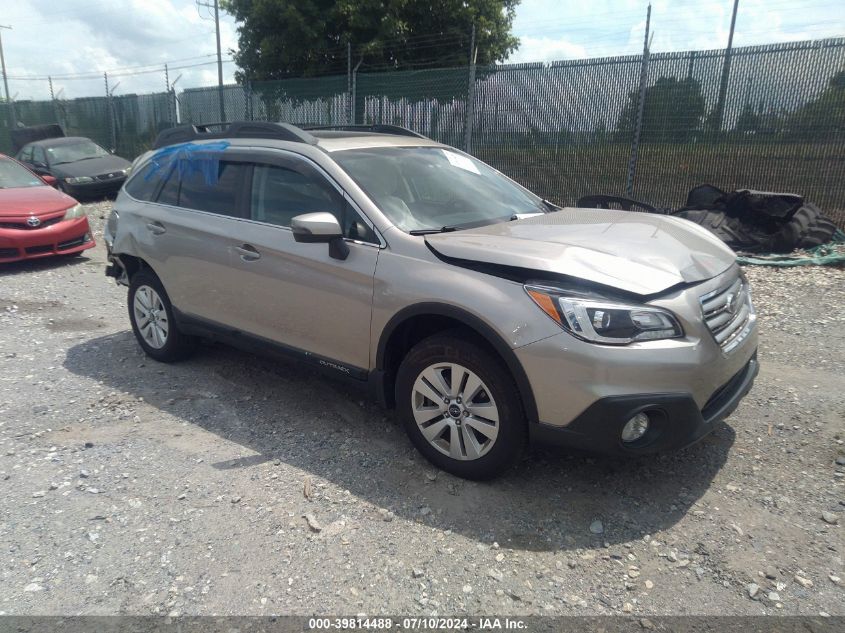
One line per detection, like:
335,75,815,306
396,332,527,480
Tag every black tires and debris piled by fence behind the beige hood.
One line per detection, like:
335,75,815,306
577,185,837,253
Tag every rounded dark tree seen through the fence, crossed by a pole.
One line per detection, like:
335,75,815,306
616,77,704,143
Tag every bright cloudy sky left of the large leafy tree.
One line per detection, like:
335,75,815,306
3,0,237,99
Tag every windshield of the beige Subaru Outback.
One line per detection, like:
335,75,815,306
332,147,547,231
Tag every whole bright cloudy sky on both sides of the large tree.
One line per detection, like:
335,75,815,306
0,0,845,100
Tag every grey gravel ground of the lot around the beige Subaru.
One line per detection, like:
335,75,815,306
0,203,845,615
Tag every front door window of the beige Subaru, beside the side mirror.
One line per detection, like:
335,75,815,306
250,165,377,242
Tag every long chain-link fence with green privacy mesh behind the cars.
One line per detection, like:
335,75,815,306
0,38,845,225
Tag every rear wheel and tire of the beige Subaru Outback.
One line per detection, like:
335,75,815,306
127,270,197,363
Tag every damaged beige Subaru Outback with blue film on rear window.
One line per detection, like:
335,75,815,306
105,122,757,478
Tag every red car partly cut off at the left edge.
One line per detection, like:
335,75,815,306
0,154,94,264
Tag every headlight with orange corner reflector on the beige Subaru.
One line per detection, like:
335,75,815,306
525,286,684,345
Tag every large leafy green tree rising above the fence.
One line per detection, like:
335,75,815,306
223,0,520,82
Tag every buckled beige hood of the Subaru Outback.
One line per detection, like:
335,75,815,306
425,208,736,295
